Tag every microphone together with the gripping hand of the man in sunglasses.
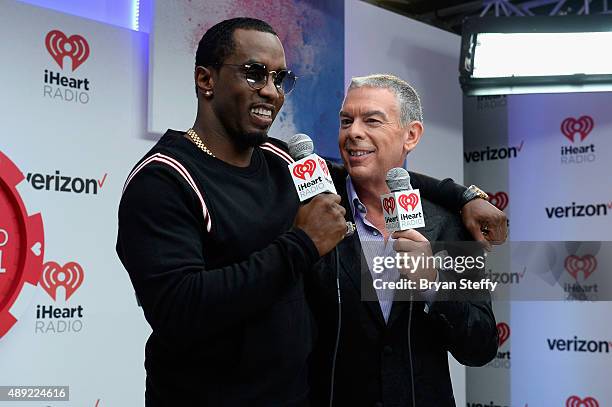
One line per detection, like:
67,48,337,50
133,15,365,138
288,134,354,256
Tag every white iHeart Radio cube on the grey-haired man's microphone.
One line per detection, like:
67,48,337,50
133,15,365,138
380,189,425,232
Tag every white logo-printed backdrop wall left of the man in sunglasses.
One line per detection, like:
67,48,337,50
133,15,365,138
0,0,151,406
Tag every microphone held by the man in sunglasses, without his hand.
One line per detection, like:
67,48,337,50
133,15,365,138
287,133,355,237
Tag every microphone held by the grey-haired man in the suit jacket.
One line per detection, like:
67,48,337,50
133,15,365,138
380,167,425,233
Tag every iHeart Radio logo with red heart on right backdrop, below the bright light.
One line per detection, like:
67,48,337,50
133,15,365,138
561,115,596,164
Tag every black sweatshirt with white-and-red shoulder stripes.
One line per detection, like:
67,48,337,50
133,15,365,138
117,130,463,407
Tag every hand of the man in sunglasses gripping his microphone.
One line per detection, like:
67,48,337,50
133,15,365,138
294,194,346,256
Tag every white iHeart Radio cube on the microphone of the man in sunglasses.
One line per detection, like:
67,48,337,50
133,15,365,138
289,154,336,202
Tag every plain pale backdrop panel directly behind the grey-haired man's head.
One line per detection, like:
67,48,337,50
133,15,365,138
344,0,463,182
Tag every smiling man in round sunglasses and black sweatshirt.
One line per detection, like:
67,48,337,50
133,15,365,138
117,18,504,407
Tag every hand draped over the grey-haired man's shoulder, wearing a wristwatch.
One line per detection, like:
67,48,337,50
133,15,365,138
461,198,508,249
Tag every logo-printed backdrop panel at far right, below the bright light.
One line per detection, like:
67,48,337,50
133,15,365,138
464,93,612,406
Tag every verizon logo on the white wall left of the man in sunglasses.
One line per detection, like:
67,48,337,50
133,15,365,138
26,170,108,195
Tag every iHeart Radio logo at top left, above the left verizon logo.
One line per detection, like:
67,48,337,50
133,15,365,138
43,29,91,104
